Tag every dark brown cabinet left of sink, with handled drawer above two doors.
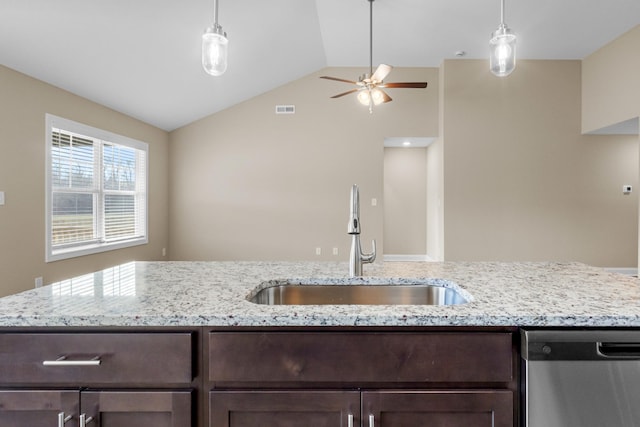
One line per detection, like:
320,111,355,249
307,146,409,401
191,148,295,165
0,332,198,427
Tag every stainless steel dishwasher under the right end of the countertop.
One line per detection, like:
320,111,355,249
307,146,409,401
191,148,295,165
521,330,640,427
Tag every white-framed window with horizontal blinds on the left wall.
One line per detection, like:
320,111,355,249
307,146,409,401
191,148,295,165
46,114,148,262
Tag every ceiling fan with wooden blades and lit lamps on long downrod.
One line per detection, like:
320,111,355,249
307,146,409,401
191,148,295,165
320,0,427,113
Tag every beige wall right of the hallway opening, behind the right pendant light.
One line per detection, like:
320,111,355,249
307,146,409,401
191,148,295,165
441,60,638,267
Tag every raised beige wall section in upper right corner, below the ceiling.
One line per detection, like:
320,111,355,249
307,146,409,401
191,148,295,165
582,25,640,133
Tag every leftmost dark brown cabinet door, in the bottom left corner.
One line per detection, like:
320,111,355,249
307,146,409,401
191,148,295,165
0,390,79,427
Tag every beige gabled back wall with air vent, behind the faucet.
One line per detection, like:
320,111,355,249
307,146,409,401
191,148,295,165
169,68,438,261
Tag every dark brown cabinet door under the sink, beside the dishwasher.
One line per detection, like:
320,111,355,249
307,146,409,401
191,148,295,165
362,390,514,427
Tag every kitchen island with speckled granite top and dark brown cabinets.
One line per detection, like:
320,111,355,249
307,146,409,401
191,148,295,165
0,262,640,427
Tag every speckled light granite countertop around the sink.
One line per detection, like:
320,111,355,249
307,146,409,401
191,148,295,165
0,261,640,327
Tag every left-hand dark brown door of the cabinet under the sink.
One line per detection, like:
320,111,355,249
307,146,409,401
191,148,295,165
209,391,360,427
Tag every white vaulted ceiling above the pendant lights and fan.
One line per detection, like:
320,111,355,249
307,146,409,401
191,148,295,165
0,0,640,130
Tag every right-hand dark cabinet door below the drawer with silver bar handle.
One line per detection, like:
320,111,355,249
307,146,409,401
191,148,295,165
80,391,192,427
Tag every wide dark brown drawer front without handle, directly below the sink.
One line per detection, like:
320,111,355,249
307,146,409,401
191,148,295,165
208,332,513,385
